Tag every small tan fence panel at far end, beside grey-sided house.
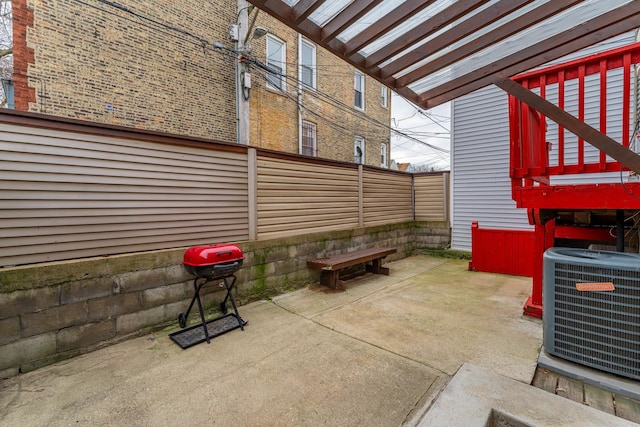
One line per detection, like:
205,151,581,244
414,172,449,221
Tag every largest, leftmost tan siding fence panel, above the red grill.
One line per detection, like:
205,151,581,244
0,123,248,266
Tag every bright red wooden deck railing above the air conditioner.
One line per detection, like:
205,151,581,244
509,43,640,209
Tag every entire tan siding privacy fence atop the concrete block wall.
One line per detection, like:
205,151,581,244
0,112,448,267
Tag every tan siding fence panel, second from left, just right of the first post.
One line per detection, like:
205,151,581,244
257,154,358,240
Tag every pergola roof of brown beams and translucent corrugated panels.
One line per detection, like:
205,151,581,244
248,0,640,113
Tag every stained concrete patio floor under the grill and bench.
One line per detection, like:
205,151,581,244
0,256,632,426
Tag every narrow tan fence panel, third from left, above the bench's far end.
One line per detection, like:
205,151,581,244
363,169,413,227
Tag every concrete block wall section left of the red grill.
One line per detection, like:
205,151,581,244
0,250,195,377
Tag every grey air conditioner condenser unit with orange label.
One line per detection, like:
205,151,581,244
543,248,640,379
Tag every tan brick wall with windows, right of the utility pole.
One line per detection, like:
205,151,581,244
242,13,391,166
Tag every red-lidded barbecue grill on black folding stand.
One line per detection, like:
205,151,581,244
169,243,247,348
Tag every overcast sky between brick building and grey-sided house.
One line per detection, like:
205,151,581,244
391,93,451,170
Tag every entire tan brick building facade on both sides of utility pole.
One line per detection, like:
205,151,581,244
13,0,391,166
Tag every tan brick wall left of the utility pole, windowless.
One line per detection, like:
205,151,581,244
21,0,236,141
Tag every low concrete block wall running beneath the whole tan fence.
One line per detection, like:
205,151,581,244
0,222,448,378
